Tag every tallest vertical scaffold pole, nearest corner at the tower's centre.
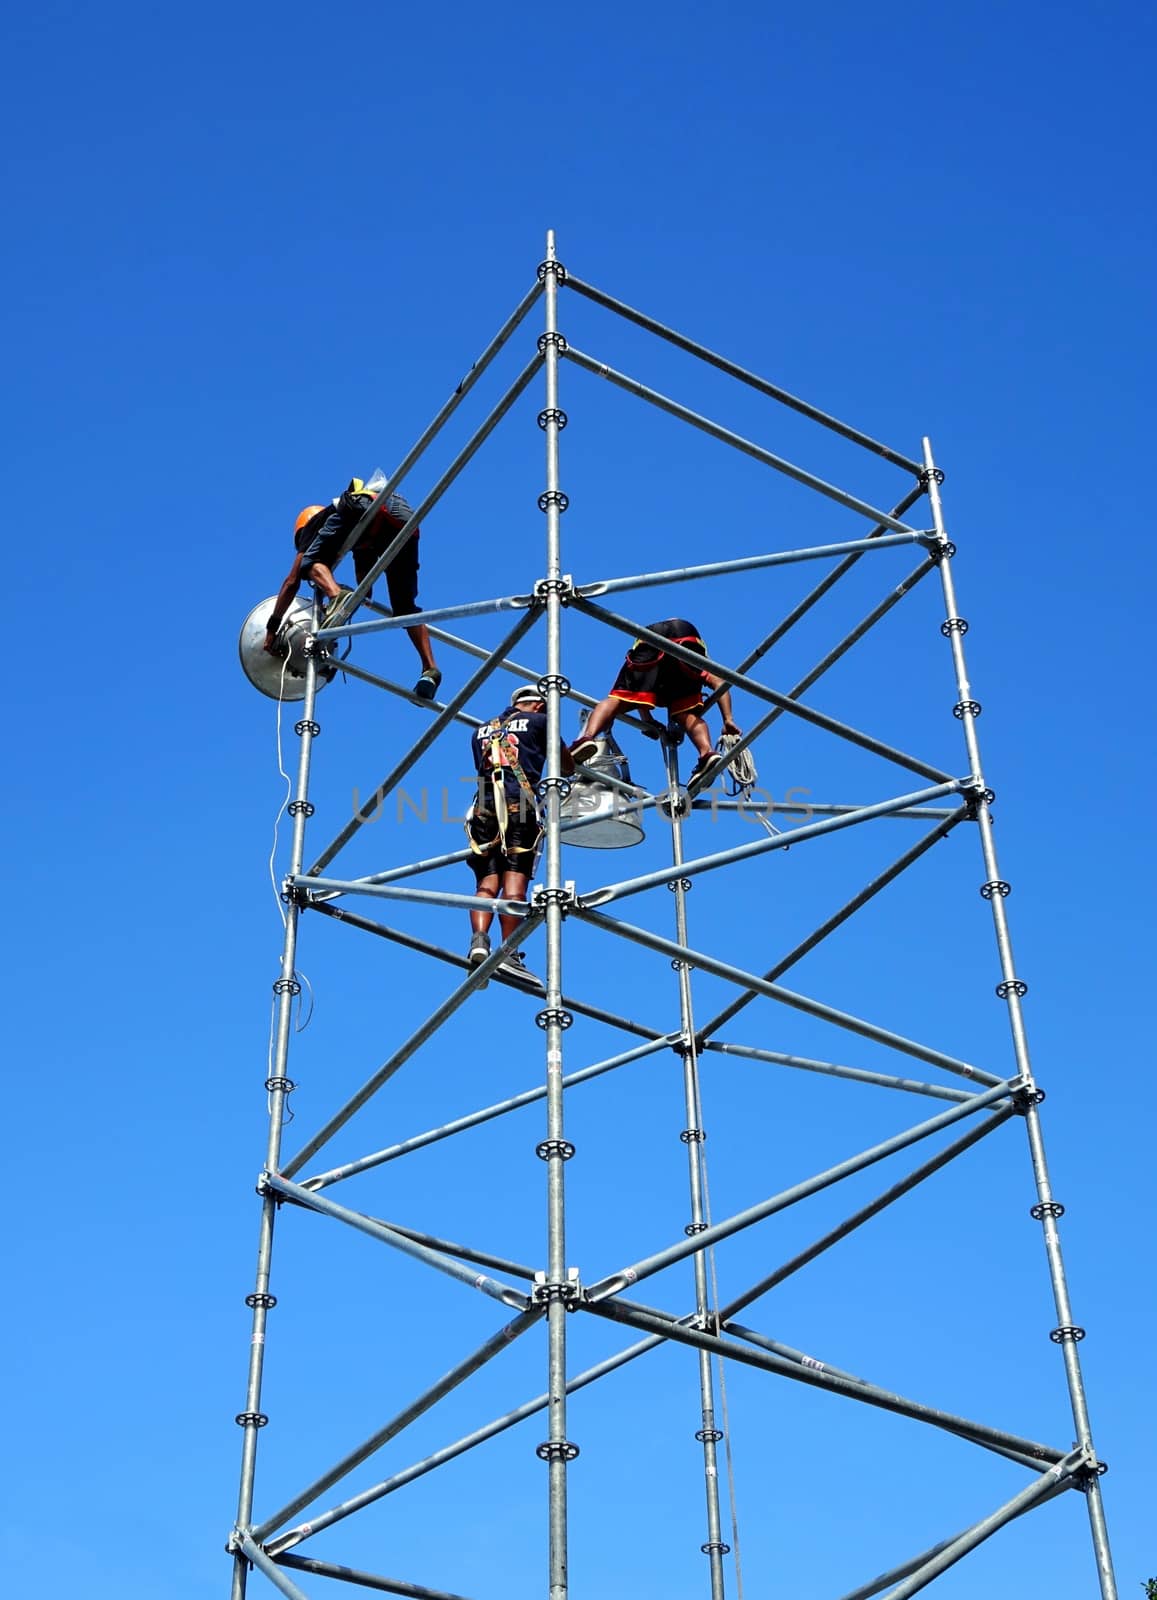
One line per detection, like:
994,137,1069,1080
538,229,578,1600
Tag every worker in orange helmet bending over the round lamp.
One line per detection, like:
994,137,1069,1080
266,472,442,699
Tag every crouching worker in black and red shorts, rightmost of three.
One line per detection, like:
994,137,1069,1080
570,616,739,782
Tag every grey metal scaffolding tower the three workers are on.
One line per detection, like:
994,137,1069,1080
227,232,1117,1600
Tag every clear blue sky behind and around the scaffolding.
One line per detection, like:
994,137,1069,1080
0,0,1157,1600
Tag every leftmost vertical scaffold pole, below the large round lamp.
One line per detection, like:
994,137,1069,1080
232,640,322,1600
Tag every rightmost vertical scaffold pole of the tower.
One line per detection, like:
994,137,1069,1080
923,438,1117,1600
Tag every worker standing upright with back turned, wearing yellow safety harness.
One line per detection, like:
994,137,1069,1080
466,683,574,989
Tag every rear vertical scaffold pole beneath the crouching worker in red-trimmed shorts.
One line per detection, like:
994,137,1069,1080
663,736,730,1600
